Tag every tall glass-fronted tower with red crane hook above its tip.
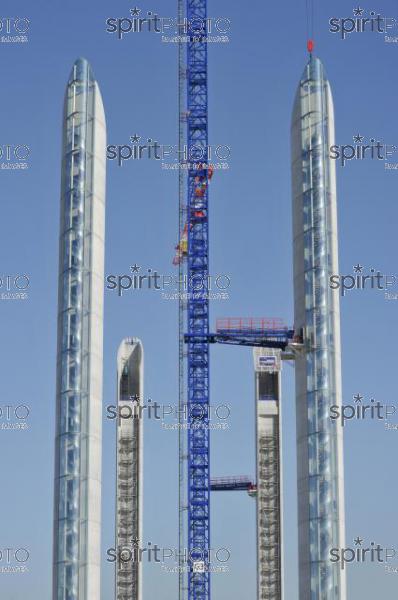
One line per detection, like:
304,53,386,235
291,55,346,600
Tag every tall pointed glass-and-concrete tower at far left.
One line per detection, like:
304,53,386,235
53,59,106,600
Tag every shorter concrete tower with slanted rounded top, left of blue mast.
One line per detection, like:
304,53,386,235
115,338,144,600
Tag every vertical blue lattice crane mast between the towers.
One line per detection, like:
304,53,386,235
186,0,210,600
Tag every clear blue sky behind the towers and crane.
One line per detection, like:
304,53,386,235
0,0,398,600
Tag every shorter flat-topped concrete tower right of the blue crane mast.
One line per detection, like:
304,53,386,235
253,348,283,600
